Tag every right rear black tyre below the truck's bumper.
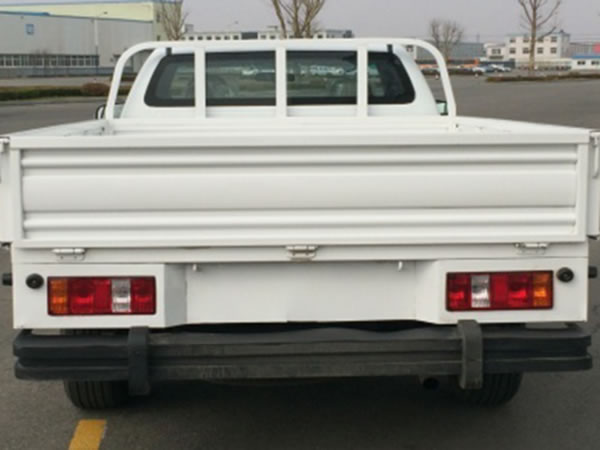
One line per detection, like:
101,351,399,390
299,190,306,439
453,373,523,406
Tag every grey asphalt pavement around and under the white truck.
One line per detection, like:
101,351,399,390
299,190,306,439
0,77,600,450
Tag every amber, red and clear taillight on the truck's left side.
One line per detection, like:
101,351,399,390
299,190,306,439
48,277,156,316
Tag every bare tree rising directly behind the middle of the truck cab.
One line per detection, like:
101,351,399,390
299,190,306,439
269,0,327,38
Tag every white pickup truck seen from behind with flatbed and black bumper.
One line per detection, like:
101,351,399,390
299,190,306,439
0,39,600,408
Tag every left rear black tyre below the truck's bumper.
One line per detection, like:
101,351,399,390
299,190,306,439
64,381,129,409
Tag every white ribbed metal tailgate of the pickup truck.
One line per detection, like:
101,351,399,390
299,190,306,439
15,136,589,247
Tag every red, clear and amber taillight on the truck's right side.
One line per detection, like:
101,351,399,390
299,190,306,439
446,272,554,311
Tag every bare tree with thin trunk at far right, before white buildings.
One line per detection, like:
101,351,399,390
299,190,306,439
517,0,562,72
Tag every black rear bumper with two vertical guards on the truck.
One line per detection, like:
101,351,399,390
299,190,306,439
14,322,592,393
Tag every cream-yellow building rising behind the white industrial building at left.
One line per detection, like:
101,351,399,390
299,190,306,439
0,0,174,41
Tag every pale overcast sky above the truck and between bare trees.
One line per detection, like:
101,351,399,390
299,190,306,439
0,0,600,42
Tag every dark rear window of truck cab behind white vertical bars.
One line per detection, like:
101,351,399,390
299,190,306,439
145,51,415,107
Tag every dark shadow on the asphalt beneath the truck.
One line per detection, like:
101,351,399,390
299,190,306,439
99,378,518,450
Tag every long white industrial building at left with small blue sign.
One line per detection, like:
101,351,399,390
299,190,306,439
0,12,153,78
